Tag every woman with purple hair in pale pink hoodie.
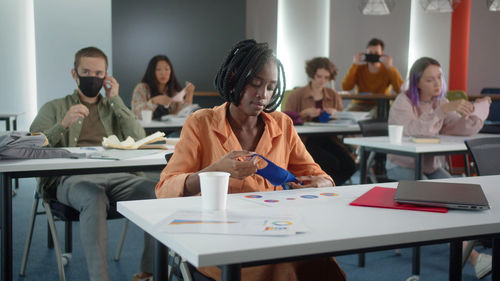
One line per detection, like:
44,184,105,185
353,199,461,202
386,57,491,279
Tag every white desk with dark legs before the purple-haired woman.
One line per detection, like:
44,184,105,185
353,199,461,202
344,134,496,183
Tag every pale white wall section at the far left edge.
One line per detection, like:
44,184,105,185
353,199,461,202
0,0,36,131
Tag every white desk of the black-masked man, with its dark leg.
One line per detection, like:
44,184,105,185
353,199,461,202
0,150,173,281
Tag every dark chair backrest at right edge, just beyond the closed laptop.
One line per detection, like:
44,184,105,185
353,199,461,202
465,137,500,176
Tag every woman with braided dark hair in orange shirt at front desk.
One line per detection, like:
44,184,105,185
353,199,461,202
156,40,345,281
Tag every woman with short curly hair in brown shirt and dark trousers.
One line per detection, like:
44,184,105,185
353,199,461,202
285,57,356,185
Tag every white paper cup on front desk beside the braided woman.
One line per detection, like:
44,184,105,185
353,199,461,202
198,172,230,210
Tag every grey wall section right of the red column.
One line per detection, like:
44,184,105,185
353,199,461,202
467,0,500,94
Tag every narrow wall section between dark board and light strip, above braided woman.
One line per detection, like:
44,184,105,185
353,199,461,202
246,0,278,53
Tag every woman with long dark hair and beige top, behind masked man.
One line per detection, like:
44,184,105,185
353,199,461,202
132,55,194,119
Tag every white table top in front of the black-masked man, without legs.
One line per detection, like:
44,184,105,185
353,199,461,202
0,148,173,172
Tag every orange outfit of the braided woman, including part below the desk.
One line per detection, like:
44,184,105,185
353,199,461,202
155,103,345,281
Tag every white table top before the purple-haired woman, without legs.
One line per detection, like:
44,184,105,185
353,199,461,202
344,134,498,153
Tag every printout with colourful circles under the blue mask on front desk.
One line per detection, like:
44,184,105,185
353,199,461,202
239,188,339,206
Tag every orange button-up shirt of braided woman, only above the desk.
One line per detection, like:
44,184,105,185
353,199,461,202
155,103,333,198
